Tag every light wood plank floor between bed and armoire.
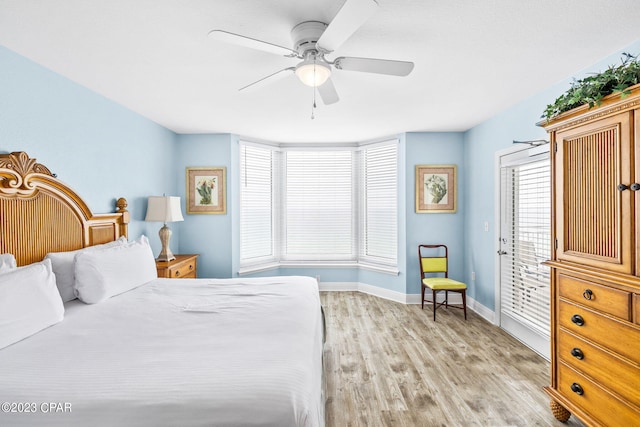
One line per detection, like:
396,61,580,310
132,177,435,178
321,292,582,427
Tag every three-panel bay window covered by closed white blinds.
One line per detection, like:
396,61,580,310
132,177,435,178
240,140,398,268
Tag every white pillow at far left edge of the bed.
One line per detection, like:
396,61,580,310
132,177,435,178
0,260,64,348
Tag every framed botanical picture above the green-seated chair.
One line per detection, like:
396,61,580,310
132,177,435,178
416,165,457,213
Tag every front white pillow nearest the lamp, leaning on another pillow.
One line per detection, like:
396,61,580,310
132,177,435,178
75,236,158,304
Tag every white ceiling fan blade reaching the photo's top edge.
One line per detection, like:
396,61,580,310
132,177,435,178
316,0,378,53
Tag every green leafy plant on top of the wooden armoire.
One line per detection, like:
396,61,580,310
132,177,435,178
542,53,640,120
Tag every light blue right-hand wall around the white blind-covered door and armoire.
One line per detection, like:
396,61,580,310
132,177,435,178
464,40,640,310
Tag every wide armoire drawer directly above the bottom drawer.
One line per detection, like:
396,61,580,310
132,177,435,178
557,328,640,406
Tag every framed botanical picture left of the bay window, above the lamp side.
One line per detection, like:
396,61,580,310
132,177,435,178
187,166,227,214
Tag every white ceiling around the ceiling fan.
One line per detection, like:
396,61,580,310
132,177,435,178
0,0,640,142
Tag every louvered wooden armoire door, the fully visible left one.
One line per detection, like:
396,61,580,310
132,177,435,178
555,112,638,274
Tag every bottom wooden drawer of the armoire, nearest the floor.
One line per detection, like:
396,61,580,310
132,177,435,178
558,363,640,426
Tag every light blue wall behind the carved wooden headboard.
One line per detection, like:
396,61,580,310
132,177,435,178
0,46,179,252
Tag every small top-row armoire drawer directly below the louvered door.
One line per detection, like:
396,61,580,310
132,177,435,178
558,273,631,320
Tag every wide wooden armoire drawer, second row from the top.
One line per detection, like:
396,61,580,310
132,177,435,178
558,299,640,361
